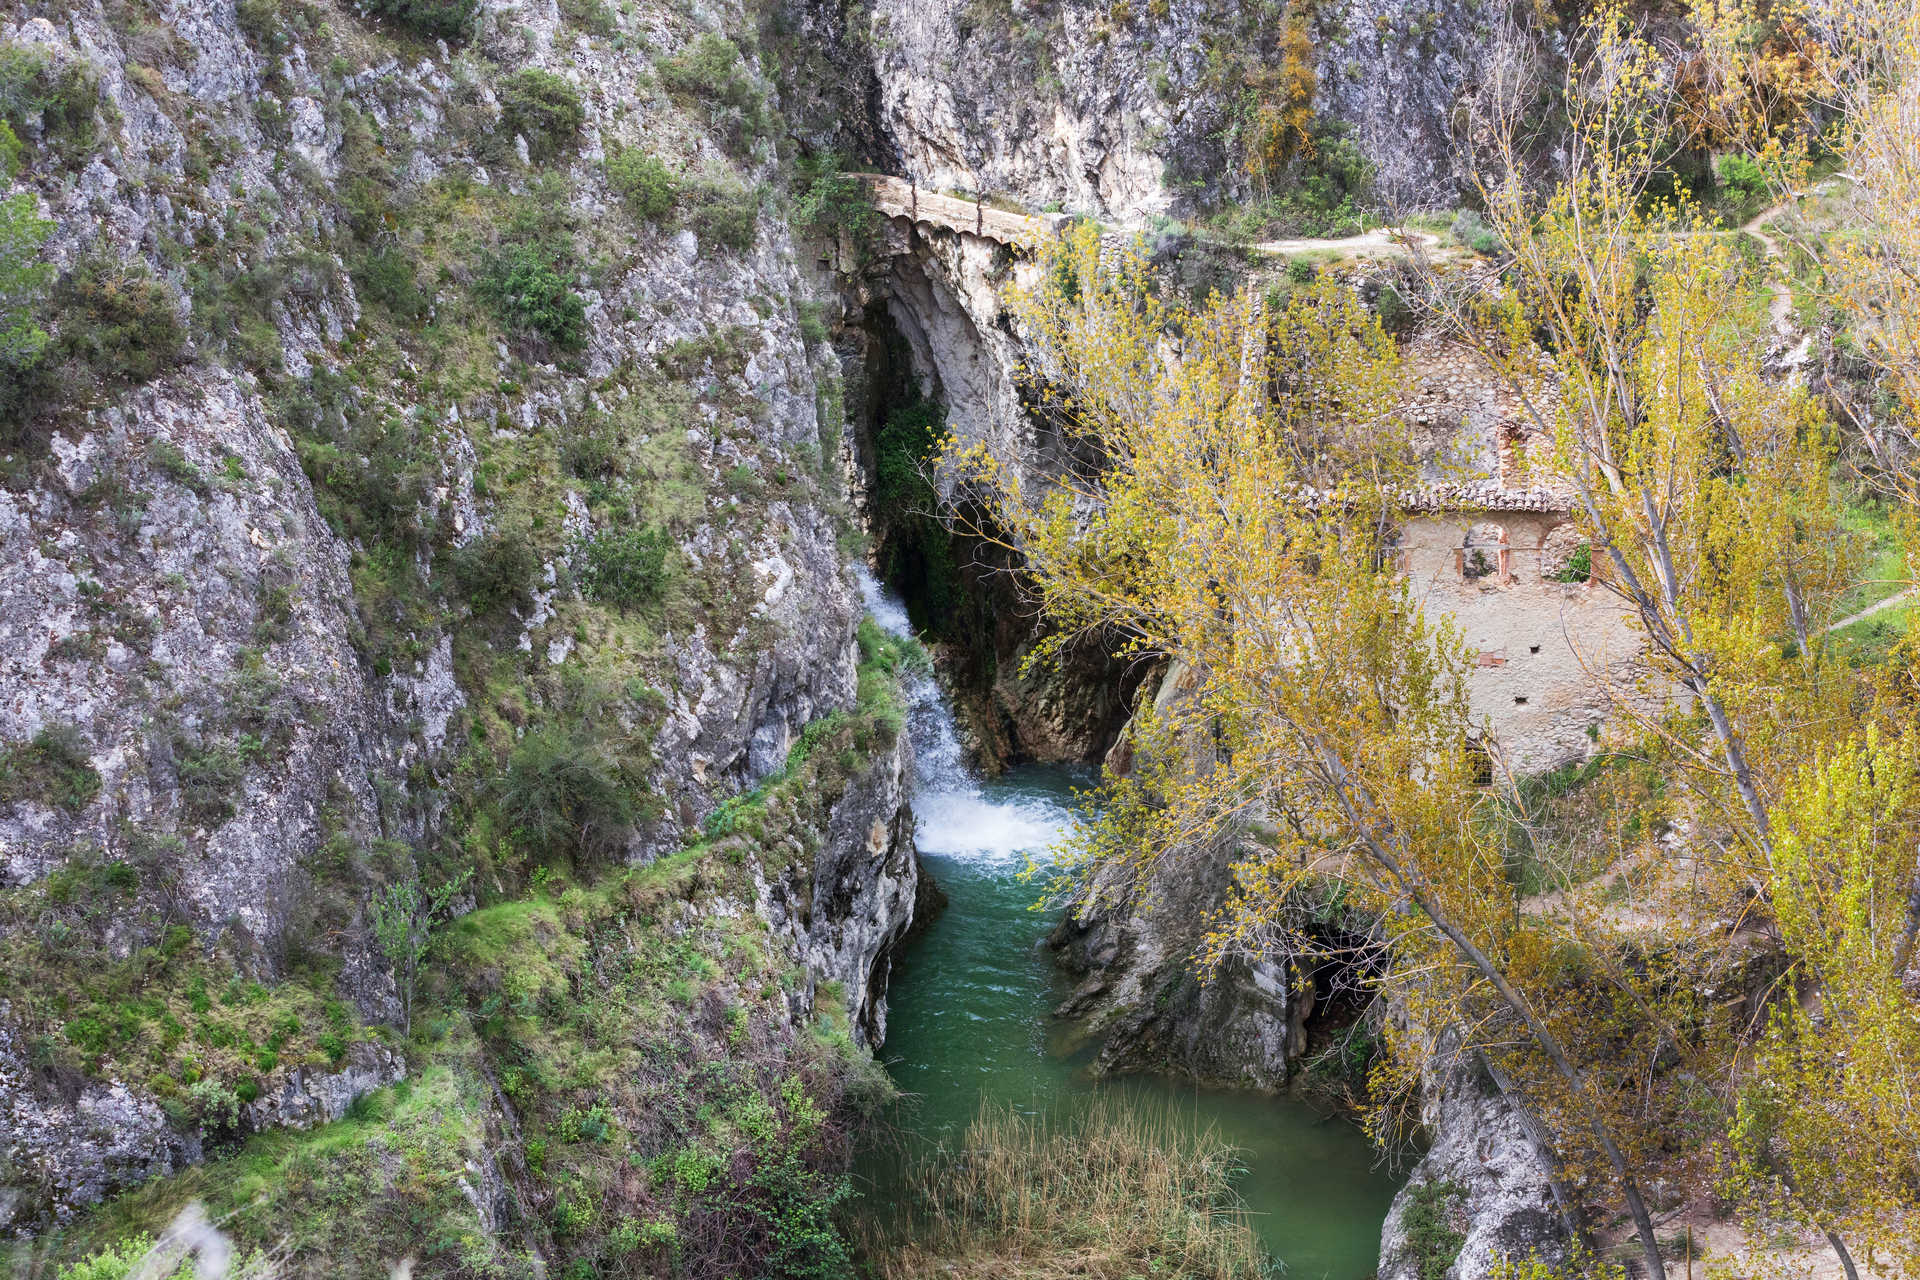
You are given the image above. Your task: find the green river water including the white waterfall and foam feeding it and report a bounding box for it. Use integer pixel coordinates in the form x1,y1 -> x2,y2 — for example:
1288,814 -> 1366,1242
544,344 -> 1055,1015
868,589 -> 1396,1280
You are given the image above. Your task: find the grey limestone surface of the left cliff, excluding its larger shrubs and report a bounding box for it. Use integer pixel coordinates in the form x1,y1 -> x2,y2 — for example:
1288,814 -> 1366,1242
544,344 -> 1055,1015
0,0 -> 914,1230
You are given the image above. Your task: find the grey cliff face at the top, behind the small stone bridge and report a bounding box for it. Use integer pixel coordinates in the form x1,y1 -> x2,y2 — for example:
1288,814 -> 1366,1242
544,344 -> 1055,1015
833,0 -> 1494,225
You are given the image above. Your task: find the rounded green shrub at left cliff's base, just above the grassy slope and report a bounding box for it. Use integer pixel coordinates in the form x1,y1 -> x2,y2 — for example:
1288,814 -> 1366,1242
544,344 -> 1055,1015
499,725 -> 634,854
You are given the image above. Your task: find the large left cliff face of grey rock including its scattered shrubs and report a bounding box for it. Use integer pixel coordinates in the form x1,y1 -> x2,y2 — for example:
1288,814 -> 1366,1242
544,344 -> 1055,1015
0,0 -> 918,1230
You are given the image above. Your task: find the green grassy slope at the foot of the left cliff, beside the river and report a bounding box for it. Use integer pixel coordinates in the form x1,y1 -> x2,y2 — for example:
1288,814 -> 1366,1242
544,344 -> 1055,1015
22,624 -> 924,1278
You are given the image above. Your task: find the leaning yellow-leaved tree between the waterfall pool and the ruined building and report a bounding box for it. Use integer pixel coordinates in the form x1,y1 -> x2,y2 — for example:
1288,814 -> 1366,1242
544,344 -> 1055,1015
947,228 -> 1665,1274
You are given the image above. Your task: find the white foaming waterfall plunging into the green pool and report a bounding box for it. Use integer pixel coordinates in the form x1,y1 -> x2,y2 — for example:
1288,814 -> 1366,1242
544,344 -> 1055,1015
854,566 -> 1073,865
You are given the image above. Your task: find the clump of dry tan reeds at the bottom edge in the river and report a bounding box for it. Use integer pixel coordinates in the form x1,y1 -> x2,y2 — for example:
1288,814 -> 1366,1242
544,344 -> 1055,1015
866,1098 -> 1271,1280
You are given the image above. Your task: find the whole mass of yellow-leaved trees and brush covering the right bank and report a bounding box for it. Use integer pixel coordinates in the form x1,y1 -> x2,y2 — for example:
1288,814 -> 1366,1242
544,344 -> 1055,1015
947,4 -> 1920,1276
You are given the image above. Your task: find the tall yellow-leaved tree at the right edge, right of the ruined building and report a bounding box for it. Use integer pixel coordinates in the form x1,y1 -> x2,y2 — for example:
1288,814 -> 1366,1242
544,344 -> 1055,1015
1440,6 -> 1920,1276
